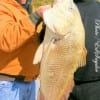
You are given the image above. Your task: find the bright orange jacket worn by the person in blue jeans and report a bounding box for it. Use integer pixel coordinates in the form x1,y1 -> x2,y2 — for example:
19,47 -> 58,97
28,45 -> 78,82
0,0 -> 39,81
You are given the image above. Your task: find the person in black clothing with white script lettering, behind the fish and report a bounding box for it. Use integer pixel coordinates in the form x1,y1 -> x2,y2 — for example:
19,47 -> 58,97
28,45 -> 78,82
68,0 -> 100,100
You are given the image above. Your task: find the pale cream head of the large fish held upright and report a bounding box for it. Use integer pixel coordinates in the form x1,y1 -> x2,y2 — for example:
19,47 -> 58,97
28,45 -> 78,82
43,0 -> 81,35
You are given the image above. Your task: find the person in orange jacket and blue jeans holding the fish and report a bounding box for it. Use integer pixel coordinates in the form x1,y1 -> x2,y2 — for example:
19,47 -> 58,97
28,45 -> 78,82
0,0 -> 50,100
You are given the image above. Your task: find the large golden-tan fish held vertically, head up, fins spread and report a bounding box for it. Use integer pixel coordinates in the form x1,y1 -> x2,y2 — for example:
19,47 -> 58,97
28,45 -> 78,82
33,0 -> 87,100
